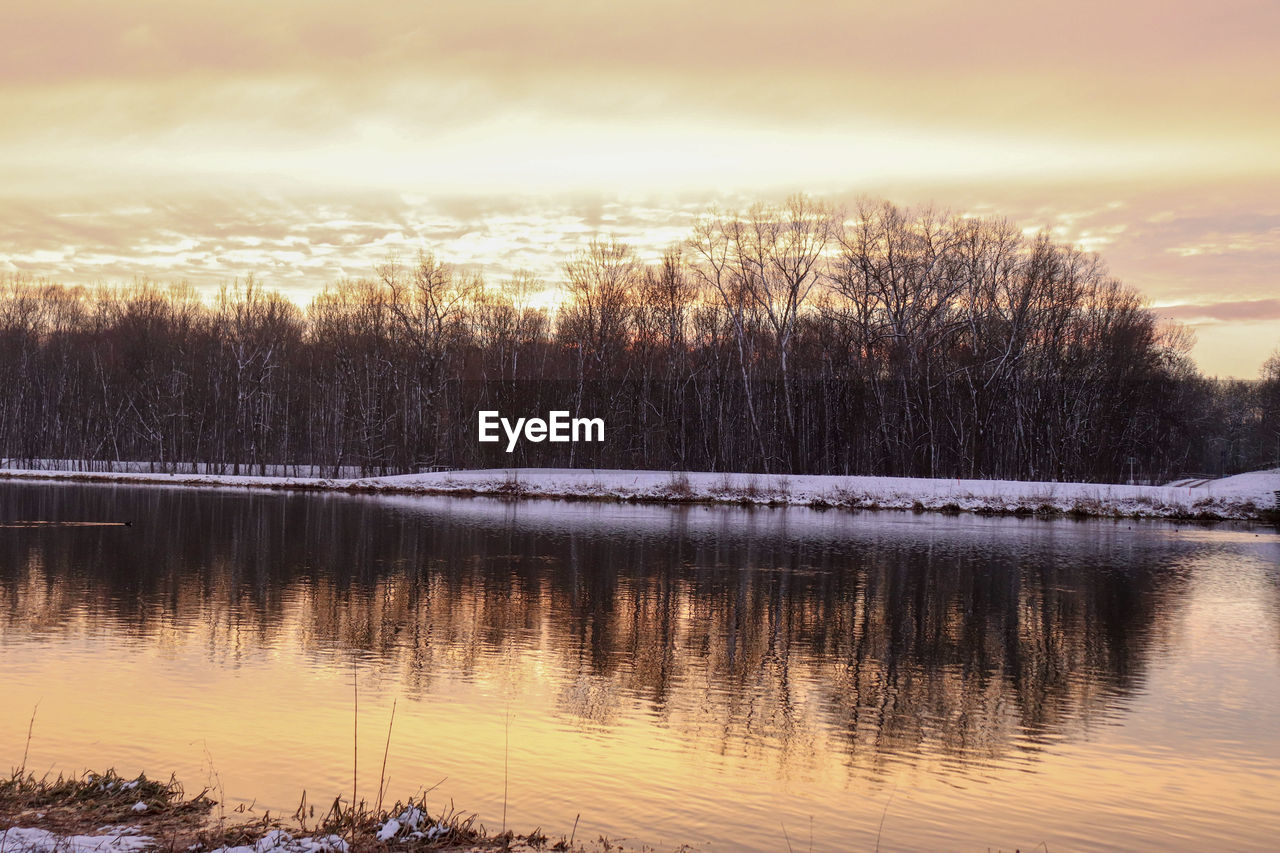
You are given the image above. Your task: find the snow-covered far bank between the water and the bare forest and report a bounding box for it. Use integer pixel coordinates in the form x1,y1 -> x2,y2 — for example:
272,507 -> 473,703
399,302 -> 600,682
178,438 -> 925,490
0,469 -> 1280,520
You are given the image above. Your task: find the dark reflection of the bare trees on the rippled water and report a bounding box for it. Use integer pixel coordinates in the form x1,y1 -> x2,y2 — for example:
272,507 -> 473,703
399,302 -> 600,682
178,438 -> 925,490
0,485 -> 1203,770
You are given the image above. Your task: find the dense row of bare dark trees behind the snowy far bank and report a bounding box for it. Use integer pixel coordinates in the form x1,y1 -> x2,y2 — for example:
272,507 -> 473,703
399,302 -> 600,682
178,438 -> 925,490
0,196 -> 1280,482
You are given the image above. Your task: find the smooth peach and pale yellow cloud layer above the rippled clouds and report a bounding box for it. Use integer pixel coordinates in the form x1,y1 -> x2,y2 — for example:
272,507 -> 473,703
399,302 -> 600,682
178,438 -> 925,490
0,0 -> 1280,179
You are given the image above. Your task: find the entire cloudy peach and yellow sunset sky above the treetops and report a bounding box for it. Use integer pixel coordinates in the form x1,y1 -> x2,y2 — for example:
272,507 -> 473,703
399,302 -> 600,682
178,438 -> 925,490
0,0 -> 1280,377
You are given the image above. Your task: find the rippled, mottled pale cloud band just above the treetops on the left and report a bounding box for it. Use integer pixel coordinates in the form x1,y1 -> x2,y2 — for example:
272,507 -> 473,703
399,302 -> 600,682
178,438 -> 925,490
0,192 -> 700,290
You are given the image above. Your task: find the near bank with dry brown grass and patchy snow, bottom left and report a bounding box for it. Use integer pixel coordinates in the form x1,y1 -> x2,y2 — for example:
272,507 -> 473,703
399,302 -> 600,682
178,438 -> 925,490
0,771 -> 640,853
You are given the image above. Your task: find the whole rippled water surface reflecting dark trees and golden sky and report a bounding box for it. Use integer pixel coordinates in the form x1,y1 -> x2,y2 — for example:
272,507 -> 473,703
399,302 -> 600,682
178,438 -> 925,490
0,485 -> 1280,849
